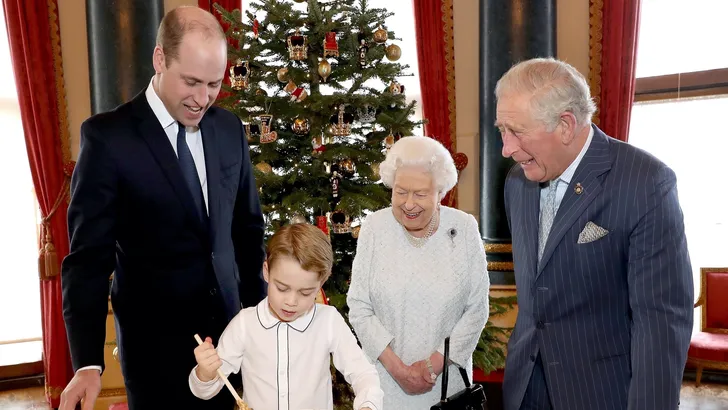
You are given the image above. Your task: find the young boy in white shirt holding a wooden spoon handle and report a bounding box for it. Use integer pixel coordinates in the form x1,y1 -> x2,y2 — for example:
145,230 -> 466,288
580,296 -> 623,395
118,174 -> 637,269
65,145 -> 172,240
189,224 -> 384,410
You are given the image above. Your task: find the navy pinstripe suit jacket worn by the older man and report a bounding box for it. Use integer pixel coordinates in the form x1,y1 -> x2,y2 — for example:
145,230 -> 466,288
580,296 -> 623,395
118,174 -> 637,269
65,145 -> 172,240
503,126 -> 694,410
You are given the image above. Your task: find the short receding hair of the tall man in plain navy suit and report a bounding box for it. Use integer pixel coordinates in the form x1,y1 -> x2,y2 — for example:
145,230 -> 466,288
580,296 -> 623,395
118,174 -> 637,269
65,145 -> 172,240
157,6 -> 227,67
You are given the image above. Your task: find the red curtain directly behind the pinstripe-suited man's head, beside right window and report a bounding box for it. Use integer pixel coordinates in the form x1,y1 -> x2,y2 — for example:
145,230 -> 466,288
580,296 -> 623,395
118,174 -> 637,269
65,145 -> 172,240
590,0 -> 641,141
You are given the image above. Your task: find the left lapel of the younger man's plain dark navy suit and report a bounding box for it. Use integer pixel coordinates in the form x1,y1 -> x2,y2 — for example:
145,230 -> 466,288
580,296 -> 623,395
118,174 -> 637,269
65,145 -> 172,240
134,93 -> 209,239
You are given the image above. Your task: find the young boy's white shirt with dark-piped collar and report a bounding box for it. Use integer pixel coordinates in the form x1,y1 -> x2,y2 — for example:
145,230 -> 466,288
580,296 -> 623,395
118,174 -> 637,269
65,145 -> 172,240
189,298 -> 384,410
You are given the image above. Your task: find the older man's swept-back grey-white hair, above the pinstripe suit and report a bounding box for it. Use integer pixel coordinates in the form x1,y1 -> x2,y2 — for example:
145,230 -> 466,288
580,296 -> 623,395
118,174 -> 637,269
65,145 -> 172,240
495,58 -> 596,130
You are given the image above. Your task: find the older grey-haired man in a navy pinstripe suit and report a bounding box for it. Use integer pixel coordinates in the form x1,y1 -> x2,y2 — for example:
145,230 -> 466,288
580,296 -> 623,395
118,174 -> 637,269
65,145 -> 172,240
496,59 -> 694,410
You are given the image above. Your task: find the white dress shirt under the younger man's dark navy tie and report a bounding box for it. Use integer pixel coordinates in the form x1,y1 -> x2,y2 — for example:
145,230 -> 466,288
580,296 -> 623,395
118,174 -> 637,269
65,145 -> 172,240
145,77 -> 209,212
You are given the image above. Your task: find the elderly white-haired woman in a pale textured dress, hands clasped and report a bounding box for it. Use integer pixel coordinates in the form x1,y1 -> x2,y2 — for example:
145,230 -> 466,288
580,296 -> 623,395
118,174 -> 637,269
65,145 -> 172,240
347,137 -> 490,410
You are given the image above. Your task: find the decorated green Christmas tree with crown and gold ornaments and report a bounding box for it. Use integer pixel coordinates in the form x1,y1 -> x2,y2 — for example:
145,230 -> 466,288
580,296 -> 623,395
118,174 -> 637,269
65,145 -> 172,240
216,0 -> 419,408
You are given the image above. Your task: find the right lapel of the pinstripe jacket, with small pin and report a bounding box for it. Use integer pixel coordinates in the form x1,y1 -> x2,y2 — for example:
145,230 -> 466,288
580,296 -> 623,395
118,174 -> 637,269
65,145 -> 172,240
536,126 -> 612,278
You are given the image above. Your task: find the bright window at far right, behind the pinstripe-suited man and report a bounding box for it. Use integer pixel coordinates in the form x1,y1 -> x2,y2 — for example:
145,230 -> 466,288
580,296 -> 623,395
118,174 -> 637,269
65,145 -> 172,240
629,0 -> 728,331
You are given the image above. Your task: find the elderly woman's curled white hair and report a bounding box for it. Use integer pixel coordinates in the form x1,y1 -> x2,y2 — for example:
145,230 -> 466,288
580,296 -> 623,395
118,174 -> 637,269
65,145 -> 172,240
379,136 -> 458,199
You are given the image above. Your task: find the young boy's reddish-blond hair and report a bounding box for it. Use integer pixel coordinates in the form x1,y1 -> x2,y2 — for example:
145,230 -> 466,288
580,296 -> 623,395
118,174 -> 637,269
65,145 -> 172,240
267,223 -> 334,283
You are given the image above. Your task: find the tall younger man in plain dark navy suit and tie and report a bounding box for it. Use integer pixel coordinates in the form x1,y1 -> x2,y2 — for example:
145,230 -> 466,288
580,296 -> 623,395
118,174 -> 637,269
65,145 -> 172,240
60,7 -> 265,410
